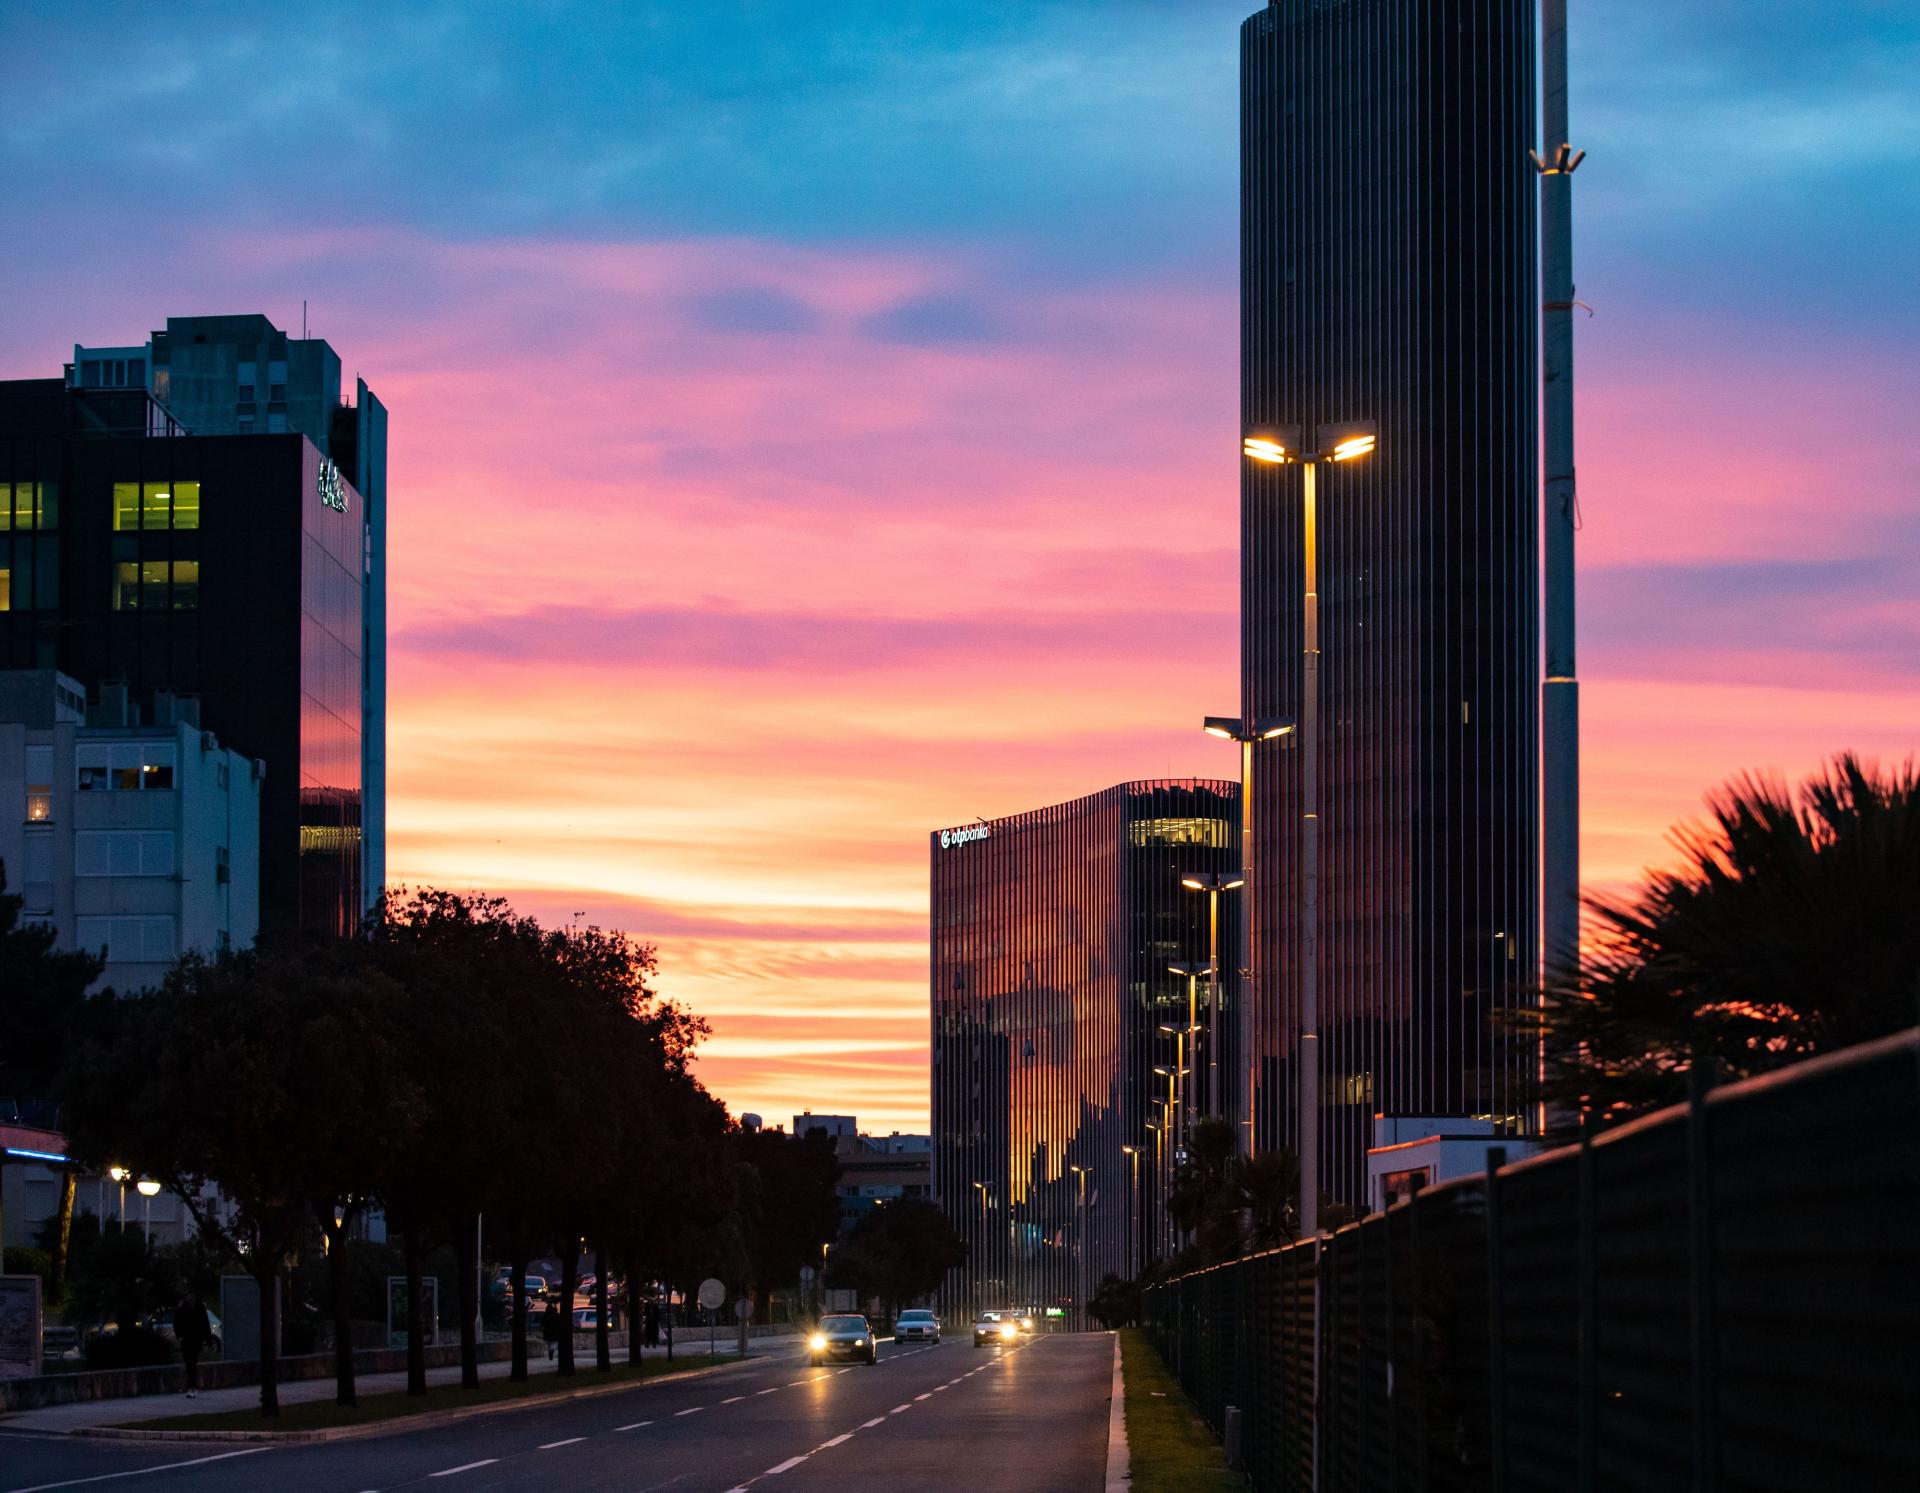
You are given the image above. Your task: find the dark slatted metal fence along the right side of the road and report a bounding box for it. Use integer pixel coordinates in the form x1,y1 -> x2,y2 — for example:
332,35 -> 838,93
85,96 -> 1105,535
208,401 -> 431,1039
1142,1031 -> 1920,1493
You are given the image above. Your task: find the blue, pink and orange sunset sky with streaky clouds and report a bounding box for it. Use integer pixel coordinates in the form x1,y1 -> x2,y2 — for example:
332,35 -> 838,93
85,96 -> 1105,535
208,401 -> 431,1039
0,0 -> 1920,1130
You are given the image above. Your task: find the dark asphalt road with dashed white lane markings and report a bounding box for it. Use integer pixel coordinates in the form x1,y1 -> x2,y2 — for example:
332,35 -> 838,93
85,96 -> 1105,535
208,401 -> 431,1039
0,1334 -> 1114,1493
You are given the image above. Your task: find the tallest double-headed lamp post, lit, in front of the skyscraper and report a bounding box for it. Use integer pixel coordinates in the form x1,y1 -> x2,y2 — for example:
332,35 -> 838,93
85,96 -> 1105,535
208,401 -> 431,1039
1240,424 -> 1379,1238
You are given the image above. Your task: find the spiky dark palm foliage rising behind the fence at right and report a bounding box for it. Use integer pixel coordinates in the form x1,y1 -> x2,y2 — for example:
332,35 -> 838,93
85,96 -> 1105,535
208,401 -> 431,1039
1528,754 -> 1920,1134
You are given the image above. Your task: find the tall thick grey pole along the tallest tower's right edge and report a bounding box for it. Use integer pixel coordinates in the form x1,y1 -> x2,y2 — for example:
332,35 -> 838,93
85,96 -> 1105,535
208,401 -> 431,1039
1538,0 -> 1580,1020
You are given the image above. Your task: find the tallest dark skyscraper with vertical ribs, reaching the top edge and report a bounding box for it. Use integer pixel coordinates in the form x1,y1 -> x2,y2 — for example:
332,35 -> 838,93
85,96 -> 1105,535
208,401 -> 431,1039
1240,0 -> 1538,1201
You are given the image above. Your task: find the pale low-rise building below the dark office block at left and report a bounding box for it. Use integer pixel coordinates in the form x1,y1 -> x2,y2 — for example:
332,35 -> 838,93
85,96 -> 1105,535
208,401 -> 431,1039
0,670 -> 265,994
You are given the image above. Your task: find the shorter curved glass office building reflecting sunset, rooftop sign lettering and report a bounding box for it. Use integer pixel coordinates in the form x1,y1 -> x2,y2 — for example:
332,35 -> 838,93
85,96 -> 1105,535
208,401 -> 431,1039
931,781 -> 1240,1320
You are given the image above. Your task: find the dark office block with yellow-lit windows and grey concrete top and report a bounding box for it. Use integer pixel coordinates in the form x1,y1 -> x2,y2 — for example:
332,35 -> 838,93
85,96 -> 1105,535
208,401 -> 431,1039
0,317 -> 386,933
